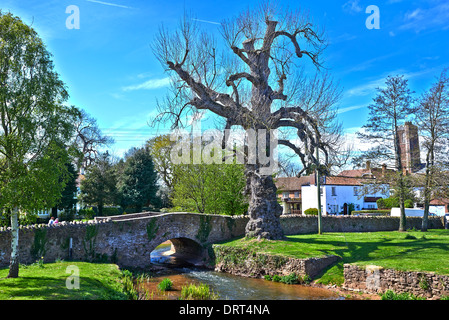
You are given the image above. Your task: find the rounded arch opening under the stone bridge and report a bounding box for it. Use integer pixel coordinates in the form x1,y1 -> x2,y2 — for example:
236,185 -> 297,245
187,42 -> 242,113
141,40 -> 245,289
150,238 -> 203,267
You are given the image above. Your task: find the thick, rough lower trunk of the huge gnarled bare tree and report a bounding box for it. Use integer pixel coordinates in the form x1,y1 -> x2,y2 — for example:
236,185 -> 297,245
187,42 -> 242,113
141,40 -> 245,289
245,173 -> 284,240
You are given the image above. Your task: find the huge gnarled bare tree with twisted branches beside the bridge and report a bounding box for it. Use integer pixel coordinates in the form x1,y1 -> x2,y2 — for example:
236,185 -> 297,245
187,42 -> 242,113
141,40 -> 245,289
153,4 -> 340,239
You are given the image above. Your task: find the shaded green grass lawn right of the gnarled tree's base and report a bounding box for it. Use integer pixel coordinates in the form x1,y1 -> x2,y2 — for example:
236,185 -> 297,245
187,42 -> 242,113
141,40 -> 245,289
222,229 -> 449,285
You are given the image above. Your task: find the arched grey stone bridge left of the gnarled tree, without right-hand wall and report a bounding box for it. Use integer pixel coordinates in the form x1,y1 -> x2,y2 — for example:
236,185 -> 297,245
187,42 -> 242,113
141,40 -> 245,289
0,213 -> 247,267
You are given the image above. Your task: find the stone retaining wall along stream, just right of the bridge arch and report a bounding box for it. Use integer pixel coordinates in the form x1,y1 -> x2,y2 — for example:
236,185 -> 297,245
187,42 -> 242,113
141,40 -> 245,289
212,245 -> 339,278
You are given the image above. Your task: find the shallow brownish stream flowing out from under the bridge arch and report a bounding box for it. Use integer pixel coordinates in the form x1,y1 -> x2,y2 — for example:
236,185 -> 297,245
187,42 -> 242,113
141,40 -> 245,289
143,244 -> 344,300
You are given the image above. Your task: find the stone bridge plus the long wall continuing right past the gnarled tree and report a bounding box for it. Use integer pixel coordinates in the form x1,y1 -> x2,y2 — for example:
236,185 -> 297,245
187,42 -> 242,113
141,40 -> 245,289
0,212 -> 443,267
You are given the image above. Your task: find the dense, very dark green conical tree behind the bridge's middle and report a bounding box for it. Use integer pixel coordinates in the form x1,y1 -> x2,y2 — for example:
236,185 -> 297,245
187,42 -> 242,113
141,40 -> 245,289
118,148 -> 160,212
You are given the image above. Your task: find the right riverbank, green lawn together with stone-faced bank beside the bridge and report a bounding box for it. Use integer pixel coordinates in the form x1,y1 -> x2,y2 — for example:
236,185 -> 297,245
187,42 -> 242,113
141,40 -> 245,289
216,229 -> 449,296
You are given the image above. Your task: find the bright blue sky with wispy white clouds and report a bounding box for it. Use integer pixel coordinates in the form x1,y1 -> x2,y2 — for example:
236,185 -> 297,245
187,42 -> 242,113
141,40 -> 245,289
0,0 -> 449,155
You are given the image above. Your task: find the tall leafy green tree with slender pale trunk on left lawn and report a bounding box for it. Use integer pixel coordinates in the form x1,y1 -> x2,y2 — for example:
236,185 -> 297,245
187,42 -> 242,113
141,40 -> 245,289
0,11 -> 79,278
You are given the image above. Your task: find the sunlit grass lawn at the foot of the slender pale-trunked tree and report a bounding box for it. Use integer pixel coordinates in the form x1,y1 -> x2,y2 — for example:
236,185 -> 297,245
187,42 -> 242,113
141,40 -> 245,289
0,261 -> 127,300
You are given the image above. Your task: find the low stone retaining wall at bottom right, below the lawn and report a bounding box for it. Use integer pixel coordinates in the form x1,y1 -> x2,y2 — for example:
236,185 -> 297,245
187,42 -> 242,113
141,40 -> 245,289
343,264 -> 449,299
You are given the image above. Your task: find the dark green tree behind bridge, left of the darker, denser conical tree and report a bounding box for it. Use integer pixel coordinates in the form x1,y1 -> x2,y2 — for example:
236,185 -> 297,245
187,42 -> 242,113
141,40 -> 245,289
81,152 -> 118,216
